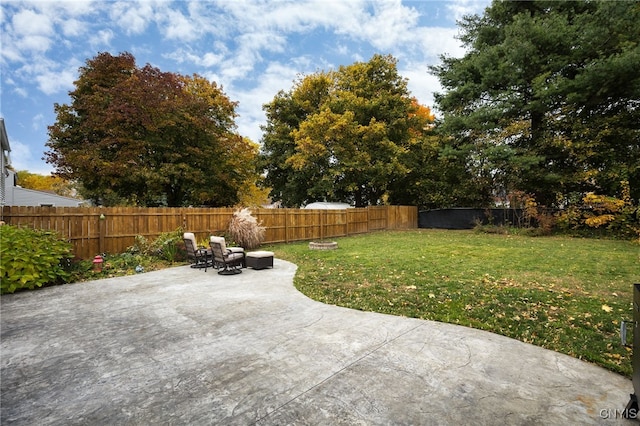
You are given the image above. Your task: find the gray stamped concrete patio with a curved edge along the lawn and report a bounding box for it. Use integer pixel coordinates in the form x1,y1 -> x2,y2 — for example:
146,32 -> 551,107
0,259 -> 635,425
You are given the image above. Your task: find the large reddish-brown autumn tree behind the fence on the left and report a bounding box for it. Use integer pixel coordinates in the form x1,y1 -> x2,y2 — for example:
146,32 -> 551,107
45,53 -> 257,206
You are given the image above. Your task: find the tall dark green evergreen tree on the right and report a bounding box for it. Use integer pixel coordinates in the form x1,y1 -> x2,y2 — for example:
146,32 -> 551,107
432,1 -> 640,205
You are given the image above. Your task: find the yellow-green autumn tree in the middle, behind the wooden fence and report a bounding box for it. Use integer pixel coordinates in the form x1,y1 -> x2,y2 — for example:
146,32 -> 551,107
261,55 -> 424,207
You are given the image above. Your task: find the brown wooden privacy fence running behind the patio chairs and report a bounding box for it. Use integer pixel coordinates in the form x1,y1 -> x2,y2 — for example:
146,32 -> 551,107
2,206 -> 418,259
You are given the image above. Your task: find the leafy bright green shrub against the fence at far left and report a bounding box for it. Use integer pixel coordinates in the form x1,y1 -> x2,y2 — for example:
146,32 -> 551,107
0,225 -> 72,294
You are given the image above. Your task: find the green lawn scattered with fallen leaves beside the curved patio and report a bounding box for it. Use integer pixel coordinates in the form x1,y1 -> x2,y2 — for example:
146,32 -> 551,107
267,229 -> 640,377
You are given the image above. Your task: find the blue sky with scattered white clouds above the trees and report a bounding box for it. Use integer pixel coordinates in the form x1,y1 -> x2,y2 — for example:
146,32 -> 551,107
0,0 -> 490,174
